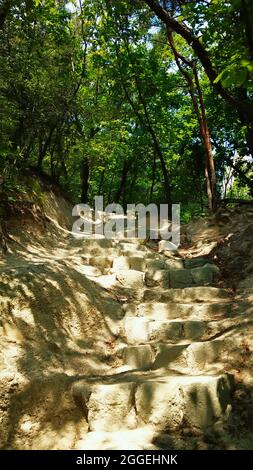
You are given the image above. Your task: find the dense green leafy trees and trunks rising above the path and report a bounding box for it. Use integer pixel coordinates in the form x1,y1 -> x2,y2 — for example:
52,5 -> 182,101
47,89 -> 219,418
0,0 -> 253,220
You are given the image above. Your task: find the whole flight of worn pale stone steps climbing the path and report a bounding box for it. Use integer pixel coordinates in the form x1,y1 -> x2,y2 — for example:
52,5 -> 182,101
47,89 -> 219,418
73,240 -> 233,449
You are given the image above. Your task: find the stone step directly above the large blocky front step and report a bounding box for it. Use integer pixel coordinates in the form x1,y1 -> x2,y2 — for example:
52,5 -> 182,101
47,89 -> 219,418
118,338 -> 225,375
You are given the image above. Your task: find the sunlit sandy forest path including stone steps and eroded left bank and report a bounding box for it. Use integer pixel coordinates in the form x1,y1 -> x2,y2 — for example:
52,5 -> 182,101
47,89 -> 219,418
0,215 -> 253,450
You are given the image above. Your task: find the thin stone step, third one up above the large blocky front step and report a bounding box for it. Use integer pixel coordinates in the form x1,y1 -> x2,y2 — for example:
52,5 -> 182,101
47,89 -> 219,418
123,302 -> 233,321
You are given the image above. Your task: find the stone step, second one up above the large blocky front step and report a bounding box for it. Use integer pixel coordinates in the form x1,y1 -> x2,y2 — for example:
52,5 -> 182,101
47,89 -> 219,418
124,314 -> 230,345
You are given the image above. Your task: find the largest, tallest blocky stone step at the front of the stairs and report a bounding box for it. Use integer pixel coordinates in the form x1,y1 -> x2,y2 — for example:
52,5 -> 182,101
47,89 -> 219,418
72,374 -> 233,433
